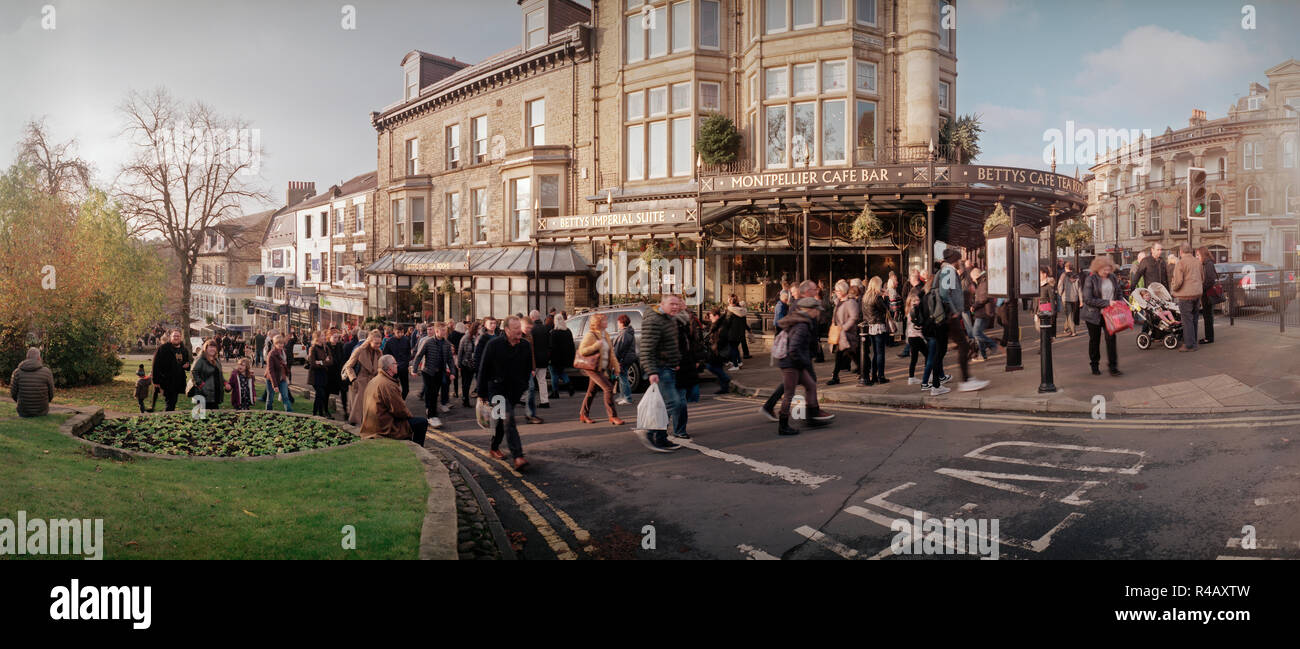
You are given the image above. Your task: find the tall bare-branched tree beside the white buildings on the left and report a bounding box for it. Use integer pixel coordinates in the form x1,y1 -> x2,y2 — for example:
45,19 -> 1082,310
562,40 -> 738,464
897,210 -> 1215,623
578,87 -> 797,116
117,88 -> 269,338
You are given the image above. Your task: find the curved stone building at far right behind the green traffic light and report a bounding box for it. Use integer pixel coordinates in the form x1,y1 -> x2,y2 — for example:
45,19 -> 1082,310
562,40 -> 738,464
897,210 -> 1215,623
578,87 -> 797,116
1087,60 -> 1300,268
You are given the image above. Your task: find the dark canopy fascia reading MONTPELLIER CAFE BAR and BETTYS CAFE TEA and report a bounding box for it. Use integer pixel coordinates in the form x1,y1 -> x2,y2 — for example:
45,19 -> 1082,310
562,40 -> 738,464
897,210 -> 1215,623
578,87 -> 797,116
699,163 -> 1087,198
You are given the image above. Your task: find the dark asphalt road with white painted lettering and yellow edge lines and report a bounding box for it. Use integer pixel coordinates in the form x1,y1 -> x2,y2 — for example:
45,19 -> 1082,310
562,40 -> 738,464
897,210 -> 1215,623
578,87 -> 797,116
411,385 -> 1300,561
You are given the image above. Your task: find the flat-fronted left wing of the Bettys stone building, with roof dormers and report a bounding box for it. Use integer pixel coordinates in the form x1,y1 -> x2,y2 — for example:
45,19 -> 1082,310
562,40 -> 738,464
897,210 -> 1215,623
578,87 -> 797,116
365,0 -> 594,323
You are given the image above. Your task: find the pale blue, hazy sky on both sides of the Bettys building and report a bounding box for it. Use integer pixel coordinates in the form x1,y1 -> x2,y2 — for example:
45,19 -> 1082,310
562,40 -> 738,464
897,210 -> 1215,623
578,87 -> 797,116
0,0 -> 1300,199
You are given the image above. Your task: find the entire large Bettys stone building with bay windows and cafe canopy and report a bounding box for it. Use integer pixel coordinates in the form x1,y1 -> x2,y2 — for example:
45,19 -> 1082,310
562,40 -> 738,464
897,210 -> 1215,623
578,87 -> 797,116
366,0 -> 1084,321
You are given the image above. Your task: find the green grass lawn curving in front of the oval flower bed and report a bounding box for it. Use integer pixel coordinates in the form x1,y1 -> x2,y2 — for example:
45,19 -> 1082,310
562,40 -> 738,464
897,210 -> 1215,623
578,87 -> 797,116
0,413 -> 429,559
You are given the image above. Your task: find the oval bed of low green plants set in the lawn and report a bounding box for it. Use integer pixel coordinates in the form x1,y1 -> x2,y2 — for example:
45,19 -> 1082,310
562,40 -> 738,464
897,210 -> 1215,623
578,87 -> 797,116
82,411 -> 356,458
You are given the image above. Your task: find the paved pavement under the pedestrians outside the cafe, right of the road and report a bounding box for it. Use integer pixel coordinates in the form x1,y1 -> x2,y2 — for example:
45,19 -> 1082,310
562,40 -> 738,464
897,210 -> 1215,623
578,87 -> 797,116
736,310 -> 1300,415
